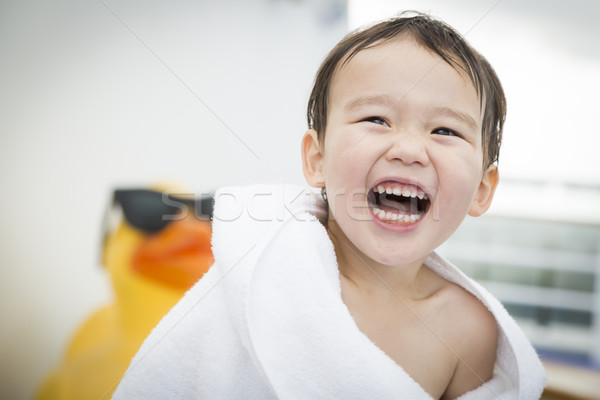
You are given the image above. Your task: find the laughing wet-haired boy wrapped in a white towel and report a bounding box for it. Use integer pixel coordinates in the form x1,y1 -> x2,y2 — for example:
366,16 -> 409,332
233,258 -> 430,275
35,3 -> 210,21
115,10 -> 544,399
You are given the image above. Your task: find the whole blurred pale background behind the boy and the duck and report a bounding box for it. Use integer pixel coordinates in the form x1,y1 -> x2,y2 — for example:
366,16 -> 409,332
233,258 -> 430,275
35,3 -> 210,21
0,0 -> 600,399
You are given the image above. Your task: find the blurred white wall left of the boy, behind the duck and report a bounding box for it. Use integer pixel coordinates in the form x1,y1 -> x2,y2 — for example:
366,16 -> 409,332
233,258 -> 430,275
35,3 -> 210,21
0,0 -> 346,399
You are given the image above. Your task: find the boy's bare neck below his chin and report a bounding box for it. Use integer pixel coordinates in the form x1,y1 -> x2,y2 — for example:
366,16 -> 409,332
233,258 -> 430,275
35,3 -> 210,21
327,220 -> 435,300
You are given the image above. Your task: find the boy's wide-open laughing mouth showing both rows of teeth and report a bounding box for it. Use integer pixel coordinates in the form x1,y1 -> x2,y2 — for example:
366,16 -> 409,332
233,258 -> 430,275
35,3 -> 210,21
367,181 -> 431,225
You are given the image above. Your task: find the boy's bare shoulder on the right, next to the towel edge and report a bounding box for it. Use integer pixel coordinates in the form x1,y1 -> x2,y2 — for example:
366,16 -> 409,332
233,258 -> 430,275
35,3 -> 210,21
442,283 -> 498,399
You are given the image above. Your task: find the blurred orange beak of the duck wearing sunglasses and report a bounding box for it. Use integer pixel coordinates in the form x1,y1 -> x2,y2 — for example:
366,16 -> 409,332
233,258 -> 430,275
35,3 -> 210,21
132,217 -> 214,291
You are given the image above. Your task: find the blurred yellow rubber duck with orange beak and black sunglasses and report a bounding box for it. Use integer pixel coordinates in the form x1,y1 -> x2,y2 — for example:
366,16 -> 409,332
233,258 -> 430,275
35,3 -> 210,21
36,189 -> 213,400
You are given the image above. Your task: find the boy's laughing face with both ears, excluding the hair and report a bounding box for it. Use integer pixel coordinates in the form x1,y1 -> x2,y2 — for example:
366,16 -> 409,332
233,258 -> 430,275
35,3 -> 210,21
303,39 -> 497,265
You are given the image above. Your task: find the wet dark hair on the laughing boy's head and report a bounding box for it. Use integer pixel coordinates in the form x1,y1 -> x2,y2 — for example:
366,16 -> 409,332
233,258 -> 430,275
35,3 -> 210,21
307,12 -> 506,169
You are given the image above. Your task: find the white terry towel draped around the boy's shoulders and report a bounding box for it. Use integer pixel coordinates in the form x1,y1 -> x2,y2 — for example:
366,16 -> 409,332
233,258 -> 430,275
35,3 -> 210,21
113,185 -> 545,400
